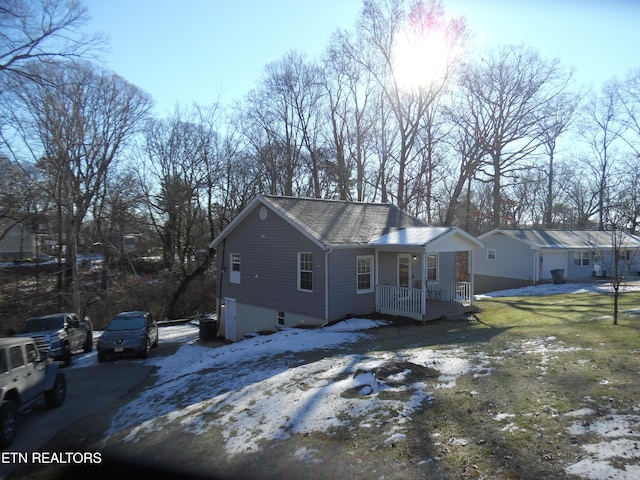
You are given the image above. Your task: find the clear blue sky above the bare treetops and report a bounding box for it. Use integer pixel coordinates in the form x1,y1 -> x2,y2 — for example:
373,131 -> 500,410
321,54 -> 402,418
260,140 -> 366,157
85,0 -> 640,115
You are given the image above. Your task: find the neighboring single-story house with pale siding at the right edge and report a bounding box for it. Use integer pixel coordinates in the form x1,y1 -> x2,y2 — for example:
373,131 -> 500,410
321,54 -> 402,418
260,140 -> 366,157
474,229 -> 640,293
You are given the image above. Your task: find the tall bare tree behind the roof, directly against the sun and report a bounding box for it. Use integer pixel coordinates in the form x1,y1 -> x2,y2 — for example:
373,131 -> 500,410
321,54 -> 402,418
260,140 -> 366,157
358,0 -> 468,209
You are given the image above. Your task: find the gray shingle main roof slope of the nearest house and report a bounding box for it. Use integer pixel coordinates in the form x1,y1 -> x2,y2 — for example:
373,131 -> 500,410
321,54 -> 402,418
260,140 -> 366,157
263,195 -> 429,246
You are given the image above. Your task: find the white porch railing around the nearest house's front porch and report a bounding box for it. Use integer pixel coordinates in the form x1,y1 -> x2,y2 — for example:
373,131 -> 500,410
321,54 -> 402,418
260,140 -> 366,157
376,280 -> 471,320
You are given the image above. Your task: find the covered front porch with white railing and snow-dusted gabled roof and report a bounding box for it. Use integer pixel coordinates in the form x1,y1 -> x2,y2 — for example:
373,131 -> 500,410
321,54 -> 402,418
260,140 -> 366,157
371,227 -> 482,322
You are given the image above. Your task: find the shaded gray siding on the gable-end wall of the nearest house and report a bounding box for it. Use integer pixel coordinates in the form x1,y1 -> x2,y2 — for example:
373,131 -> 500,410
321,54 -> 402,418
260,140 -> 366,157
216,204 -> 325,323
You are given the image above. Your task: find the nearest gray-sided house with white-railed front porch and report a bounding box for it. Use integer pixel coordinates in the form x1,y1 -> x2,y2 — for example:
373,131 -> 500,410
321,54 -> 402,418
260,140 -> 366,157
210,195 -> 481,341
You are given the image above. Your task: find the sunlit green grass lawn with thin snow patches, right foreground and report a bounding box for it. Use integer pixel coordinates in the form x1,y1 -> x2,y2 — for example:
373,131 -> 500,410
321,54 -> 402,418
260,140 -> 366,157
424,292 -> 640,478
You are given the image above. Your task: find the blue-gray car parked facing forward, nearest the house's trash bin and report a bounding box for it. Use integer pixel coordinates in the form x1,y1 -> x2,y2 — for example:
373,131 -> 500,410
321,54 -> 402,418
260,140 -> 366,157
96,311 -> 158,362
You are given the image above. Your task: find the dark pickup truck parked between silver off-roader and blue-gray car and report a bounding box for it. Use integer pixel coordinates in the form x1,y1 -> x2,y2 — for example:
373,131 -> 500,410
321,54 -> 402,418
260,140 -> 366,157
13,313 -> 93,366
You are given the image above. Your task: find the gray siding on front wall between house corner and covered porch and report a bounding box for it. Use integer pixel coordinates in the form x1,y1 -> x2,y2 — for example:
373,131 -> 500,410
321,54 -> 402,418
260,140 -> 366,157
329,248 -> 377,321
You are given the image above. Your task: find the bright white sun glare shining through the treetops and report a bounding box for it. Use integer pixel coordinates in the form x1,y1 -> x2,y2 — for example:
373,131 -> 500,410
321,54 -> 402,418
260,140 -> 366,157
393,28 -> 451,90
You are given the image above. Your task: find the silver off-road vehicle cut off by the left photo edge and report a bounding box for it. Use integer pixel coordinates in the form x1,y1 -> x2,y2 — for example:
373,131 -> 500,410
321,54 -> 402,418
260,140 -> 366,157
0,337 -> 67,448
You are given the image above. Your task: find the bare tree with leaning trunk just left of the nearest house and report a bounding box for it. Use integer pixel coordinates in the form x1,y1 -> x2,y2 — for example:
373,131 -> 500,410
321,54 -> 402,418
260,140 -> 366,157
142,105 -> 228,318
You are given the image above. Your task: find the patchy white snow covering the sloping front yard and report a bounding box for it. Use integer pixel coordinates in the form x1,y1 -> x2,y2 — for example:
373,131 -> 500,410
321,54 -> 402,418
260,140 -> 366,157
71,284 -> 640,479
